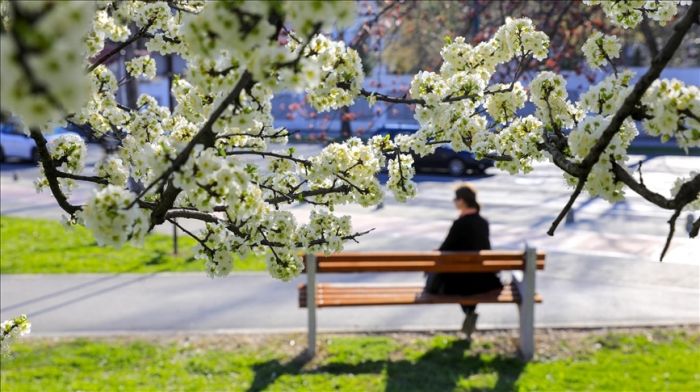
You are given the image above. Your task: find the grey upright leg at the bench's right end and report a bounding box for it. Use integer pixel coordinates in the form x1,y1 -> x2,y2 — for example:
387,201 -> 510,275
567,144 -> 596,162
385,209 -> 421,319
519,247 -> 537,361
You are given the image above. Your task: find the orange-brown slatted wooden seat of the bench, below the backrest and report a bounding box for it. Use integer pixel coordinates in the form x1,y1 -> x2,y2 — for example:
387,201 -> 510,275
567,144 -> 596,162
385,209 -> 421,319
299,283 -> 542,308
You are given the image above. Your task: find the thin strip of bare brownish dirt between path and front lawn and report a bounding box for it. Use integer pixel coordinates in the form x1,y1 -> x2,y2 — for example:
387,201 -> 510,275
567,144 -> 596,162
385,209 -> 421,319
24,325 -> 700,362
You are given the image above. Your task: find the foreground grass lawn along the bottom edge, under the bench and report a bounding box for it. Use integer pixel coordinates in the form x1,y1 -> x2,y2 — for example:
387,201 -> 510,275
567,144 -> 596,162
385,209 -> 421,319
2,328 -> 700,392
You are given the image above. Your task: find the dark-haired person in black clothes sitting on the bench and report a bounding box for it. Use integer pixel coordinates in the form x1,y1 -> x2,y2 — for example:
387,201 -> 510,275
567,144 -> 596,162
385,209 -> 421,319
425,184 -> 503,337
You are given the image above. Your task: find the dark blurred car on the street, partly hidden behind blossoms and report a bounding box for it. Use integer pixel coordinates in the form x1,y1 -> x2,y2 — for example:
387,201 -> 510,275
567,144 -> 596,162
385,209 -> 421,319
373,124 -> 493,176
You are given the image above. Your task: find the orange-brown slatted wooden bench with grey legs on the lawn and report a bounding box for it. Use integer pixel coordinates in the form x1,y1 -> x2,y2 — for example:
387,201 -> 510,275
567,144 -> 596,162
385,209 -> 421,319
299,248 -> 545,359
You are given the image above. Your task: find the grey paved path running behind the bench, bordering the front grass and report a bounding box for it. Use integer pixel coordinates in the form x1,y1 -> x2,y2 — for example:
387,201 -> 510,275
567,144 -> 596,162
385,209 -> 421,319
0,253 -> 700,335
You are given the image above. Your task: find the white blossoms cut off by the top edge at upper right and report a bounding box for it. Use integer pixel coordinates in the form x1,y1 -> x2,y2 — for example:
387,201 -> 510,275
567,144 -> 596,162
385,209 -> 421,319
583,0 -> 688,29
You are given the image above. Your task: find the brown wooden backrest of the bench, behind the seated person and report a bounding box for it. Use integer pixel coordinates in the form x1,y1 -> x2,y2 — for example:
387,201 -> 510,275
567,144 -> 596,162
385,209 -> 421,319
305,250 -> 545,273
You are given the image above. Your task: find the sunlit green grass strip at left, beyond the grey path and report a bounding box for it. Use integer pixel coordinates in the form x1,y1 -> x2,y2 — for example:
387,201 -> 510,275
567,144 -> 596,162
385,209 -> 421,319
0,216 -> 265,274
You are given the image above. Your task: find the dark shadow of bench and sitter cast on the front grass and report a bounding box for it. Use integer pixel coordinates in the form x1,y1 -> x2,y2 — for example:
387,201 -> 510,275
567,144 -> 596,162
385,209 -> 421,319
248,341 -> 525,392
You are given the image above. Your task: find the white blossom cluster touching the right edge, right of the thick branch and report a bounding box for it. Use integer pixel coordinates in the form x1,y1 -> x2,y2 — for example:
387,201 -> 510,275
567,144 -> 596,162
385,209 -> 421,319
642,79 -> 700,149
